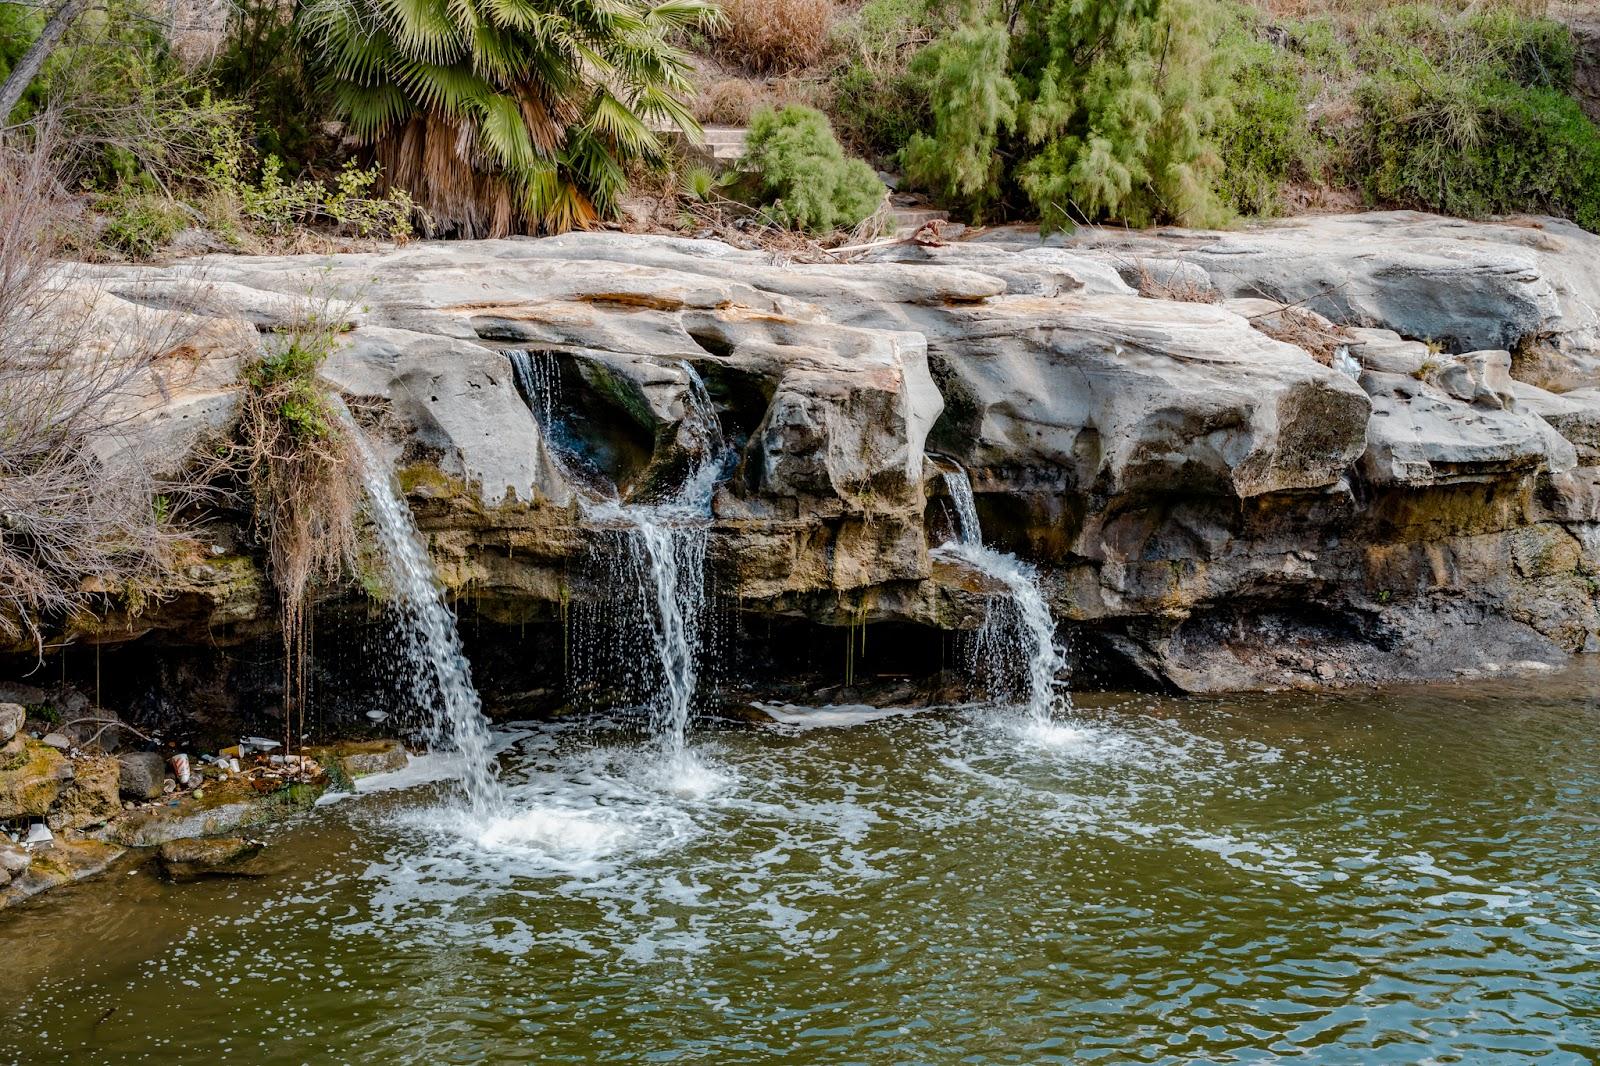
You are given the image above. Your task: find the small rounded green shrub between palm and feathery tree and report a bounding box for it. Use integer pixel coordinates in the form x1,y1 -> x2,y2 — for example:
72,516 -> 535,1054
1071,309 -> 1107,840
741,106 -> 885,234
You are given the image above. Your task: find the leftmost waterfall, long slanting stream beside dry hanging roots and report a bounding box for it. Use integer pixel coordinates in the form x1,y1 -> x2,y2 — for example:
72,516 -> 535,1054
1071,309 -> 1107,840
347,419 -> 501,815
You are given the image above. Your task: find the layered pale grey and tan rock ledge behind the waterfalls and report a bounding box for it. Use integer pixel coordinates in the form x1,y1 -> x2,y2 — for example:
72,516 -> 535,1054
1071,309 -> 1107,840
40,213 -> 1600,691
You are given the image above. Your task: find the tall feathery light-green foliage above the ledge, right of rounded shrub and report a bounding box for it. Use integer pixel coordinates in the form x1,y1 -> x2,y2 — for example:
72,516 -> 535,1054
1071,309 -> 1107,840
904,0 -> 1227,227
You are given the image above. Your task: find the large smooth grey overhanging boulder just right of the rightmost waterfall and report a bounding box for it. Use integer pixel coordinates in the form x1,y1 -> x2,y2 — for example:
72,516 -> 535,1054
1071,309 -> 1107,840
930,295 -> 1370,498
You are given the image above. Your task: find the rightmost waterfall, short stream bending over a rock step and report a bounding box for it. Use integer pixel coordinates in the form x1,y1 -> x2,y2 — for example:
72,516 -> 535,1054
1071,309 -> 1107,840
936,467 -> 1067,725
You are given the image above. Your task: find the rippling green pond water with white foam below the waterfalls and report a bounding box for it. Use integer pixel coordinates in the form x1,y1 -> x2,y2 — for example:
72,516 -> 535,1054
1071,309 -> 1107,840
0,666 -> 1600,1064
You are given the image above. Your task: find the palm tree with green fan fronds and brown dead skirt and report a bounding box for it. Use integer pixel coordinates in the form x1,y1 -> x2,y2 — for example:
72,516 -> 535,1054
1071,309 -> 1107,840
298,0 -> 720,237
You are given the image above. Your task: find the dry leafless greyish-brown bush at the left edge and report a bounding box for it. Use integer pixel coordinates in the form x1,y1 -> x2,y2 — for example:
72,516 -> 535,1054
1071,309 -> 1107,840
0,123 -> 196,648
